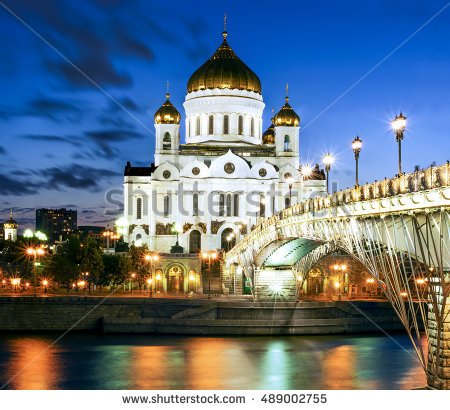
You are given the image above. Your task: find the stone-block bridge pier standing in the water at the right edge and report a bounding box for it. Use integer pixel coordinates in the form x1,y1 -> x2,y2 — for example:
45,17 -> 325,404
427,286 -> 450,390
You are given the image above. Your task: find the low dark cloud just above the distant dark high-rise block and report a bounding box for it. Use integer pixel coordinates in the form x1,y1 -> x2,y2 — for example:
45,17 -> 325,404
38,163 -> 119,192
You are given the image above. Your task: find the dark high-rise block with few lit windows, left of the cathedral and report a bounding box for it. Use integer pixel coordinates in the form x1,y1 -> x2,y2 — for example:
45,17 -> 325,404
36,208 -> 77,244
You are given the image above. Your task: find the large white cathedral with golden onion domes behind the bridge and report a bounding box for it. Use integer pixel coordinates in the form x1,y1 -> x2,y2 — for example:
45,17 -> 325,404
123,25 -> 326,294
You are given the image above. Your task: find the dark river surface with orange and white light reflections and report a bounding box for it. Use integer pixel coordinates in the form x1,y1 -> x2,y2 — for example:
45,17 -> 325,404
0,334 -> 425,389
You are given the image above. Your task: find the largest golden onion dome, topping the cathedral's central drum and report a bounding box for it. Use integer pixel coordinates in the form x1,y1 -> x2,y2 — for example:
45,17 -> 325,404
187,31 -> 261,94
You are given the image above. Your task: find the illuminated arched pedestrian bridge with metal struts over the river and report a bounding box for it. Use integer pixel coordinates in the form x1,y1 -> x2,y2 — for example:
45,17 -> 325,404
225,162 -> 450,388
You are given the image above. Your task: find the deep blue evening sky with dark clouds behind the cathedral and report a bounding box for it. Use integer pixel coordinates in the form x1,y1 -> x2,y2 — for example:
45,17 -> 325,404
0,0 -> 450,229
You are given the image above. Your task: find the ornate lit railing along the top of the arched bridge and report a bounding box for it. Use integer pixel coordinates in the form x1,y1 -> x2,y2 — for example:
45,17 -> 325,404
280,161 -> 450,223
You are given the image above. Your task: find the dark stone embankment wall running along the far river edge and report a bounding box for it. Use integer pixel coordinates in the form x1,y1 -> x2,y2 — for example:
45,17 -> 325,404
0,296 -> 403,335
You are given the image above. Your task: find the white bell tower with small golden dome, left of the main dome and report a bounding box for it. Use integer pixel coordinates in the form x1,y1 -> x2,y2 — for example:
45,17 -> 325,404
154,87 -> 181,166
